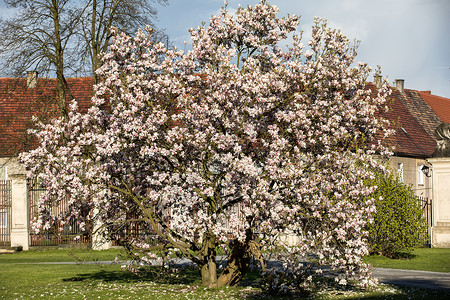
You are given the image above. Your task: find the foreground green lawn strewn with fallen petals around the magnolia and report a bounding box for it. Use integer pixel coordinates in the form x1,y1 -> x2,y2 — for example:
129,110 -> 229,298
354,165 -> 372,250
0,249 -> 450,300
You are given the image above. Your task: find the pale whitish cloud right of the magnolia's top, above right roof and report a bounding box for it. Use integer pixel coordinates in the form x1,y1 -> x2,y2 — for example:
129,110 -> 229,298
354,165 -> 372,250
273,0 -> 450,97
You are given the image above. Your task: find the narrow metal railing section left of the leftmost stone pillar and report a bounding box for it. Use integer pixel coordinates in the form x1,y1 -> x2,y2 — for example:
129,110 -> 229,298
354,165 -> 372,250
0,180 -> 12,246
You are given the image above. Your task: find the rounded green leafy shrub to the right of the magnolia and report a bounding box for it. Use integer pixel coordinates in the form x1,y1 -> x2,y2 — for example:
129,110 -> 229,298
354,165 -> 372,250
368,173 -> 428,258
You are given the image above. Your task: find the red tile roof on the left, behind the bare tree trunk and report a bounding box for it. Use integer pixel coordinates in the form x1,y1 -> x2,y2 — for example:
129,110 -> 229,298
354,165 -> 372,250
0,78 -> 92,157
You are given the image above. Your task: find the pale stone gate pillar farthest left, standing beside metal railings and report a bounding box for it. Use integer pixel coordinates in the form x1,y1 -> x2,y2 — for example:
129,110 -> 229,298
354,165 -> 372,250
9,174 -> 30,250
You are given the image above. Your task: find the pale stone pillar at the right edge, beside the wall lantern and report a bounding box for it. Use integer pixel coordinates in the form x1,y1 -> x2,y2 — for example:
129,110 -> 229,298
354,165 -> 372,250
428,157 -> 450,248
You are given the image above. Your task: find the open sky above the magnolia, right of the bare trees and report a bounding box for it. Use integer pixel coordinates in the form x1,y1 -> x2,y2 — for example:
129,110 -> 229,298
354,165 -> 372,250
156,0 -> 450,98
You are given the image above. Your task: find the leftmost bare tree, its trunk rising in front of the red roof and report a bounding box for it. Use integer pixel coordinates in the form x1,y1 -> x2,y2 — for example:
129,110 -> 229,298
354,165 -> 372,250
0,0 -> 82,116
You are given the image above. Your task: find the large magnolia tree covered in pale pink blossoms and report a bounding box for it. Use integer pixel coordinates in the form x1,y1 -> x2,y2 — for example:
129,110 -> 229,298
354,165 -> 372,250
21,1 -> 394,286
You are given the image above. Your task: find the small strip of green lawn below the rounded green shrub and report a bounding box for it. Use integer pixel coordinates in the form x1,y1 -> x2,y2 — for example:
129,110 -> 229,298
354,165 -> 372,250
364,248 -> 450,272
